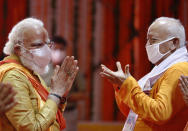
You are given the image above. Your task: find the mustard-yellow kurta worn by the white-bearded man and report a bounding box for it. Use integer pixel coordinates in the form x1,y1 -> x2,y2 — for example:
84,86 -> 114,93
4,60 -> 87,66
0,56 -> 64,131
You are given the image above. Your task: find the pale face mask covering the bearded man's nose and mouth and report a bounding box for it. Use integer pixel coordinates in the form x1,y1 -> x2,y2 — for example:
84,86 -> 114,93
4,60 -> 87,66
20,45 -> 51,74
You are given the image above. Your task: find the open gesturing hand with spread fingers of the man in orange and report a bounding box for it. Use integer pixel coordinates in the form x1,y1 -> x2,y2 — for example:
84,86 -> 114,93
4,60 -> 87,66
100,62 -> 131,86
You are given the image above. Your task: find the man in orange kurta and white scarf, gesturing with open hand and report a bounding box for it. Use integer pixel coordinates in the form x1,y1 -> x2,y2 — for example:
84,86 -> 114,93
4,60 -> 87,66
101,17 -> 188,131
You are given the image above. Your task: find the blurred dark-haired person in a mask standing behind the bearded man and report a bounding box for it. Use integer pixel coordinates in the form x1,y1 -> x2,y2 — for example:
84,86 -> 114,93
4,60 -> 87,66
42,36 -> 86,131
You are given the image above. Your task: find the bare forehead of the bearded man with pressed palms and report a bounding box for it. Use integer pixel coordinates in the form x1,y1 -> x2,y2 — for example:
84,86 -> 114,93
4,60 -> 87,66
22,25 -> 49,43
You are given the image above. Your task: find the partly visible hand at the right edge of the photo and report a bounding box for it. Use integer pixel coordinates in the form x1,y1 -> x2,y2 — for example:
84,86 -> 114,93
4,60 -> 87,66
179,76 -> 188,105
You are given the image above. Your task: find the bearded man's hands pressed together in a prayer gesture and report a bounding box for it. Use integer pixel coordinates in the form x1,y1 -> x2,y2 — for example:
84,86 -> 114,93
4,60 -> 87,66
51,56 -> 79,97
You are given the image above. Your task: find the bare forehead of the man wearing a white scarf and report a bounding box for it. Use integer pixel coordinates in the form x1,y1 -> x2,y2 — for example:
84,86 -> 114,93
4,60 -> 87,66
147,21 -> 169,39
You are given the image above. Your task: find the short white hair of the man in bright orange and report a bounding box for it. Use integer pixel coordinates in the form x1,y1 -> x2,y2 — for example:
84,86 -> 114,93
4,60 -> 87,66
148,17 -> 186,47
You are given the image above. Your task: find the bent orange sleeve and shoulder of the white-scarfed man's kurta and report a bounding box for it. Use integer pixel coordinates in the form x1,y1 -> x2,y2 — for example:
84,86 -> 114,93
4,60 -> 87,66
116,62 -> 188,125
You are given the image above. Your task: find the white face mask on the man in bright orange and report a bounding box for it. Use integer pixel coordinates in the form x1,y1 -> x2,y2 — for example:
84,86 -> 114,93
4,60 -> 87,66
146,37 -> 175,64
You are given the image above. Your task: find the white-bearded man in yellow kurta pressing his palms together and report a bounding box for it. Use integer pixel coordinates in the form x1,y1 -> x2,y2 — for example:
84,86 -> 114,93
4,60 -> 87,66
0,18 -> 79,131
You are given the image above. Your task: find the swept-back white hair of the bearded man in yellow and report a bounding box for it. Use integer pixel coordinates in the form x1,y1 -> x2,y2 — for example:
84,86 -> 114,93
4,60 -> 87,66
3,18 -> 44,55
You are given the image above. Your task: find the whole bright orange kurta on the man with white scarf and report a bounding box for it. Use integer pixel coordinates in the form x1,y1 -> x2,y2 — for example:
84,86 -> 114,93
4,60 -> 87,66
115,62 -> 188,131
